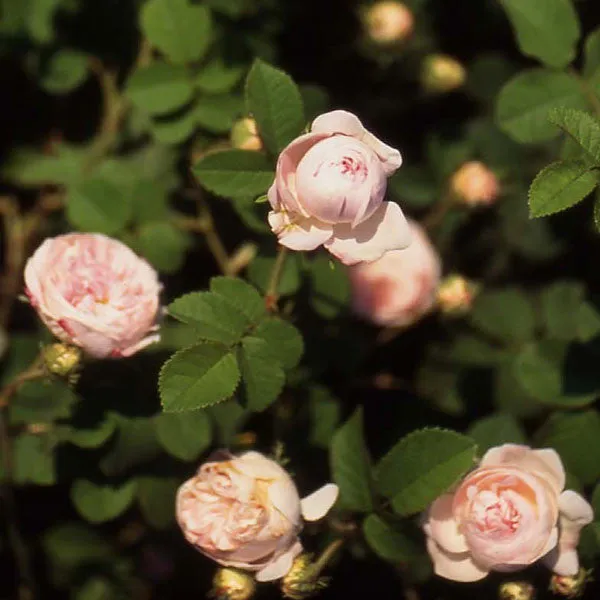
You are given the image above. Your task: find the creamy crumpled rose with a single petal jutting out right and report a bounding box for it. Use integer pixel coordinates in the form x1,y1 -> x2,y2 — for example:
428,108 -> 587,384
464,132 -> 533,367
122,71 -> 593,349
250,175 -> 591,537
177,452 -> 338,581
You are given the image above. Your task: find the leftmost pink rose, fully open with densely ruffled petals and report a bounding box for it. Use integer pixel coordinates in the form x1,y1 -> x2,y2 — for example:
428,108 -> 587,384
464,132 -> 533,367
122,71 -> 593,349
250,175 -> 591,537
25,233 -> 161,358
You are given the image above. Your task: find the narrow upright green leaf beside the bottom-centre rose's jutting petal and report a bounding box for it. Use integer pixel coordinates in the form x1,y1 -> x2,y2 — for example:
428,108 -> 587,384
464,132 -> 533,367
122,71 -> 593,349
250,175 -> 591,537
330,408 -> 373,512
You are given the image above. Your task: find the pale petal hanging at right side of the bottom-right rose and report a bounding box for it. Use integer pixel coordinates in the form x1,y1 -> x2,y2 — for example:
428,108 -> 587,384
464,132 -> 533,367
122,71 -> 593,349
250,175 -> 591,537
544,490 -> 594,577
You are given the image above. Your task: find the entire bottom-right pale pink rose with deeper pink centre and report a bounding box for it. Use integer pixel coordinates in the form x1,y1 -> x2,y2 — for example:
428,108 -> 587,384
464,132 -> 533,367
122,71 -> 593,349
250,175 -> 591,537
424,444 -> 593,581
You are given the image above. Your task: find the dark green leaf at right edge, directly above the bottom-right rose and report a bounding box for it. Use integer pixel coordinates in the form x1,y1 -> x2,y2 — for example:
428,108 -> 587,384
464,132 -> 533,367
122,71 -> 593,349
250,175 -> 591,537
536,409 -> 600,485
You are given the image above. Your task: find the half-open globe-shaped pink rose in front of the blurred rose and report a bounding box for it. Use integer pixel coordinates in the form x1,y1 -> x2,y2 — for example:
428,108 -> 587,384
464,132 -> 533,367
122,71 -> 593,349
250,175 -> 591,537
269,110 -> 410,265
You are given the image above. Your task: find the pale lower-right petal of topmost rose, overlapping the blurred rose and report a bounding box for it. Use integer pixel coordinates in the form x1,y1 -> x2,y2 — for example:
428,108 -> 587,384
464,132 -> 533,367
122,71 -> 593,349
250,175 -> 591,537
324,202 -> 411,265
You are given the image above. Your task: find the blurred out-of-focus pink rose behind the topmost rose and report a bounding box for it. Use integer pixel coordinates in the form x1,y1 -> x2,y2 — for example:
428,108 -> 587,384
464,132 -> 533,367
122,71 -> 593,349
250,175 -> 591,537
349,221 -> 441,327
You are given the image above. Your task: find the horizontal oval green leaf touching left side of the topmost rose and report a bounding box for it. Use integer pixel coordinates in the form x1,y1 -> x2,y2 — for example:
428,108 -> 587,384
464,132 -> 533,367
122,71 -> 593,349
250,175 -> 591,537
192,150 -> 275,198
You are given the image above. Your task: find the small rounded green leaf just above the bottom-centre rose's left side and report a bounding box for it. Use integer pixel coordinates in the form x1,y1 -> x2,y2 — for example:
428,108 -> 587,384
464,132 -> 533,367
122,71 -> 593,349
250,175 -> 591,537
156,411 -> 212,460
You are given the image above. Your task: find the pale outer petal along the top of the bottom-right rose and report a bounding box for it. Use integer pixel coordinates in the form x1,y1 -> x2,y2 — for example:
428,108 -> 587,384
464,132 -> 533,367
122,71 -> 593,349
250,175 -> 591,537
480,444 -> 565,494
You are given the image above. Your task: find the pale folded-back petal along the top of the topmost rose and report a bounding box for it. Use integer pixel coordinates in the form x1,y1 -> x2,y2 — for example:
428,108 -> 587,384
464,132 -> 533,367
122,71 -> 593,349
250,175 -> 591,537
311,110 -> 402,175
